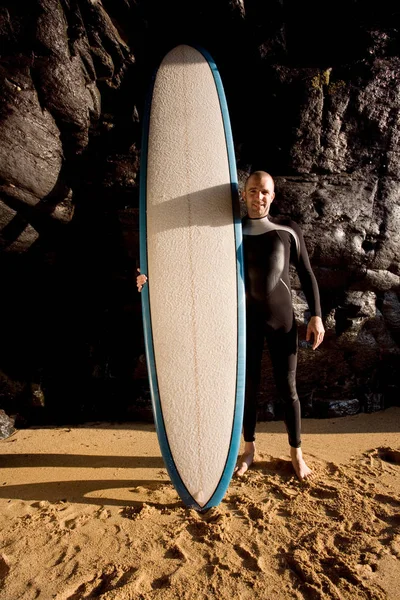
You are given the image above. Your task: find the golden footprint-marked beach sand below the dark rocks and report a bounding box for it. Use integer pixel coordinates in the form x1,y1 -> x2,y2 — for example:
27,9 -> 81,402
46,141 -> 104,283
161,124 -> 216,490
0,407 -> 400,600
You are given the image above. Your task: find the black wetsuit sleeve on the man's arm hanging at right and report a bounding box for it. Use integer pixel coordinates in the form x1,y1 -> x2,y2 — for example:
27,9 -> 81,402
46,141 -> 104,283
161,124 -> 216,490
290,221 -> 322,317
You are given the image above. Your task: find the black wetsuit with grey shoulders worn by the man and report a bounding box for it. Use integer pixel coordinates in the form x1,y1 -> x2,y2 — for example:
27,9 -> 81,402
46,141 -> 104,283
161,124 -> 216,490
243,216 -> 321,448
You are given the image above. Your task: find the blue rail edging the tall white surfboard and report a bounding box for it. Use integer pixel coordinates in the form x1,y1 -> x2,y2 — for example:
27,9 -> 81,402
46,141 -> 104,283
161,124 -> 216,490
139,44 -> 246,512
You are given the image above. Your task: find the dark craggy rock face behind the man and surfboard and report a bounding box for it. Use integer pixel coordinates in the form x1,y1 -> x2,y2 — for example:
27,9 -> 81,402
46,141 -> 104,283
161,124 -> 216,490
0,0 -> 400,426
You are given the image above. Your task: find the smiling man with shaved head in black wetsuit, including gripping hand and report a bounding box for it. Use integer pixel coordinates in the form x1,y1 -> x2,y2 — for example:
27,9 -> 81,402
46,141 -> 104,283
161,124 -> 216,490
137,171 -> 324,480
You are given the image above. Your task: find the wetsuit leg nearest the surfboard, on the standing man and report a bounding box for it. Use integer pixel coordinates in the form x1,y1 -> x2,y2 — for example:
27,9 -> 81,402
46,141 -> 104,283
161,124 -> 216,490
243,308 -> 265,442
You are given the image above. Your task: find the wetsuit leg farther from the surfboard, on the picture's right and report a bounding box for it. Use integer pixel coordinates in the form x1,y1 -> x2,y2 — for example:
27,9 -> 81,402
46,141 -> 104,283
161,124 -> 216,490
266,318 -> 301,448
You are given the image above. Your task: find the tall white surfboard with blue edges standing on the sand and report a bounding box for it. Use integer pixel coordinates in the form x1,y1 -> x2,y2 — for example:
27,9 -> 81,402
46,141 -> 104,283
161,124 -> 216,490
139,45 -> 245,511
